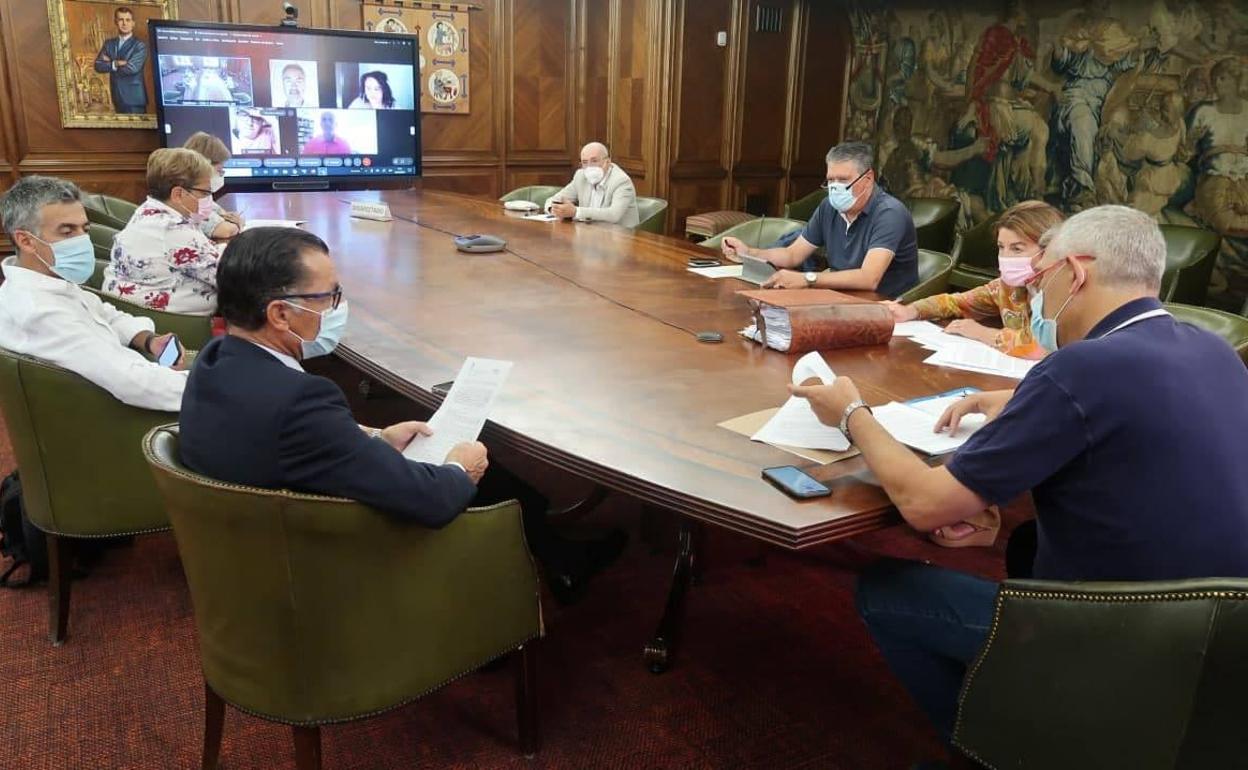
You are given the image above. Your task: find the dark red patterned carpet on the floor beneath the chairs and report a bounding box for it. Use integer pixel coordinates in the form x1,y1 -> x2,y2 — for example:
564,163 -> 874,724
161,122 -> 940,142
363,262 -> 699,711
0,411 -> 1001,770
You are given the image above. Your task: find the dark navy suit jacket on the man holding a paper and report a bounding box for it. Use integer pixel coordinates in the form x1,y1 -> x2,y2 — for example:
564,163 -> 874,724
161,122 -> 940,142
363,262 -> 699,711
178,336 -> 477,527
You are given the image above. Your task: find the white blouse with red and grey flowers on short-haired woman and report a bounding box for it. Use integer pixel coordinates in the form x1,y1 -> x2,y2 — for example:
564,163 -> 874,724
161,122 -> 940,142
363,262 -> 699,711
102,197 -> 221,316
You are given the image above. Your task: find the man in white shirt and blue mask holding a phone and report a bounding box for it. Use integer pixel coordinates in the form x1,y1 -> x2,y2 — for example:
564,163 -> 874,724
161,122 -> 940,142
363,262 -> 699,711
0,176 -> 186,412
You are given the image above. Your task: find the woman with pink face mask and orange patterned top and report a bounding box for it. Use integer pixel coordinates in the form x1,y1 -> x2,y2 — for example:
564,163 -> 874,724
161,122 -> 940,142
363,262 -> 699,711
885,201 -> 1062,358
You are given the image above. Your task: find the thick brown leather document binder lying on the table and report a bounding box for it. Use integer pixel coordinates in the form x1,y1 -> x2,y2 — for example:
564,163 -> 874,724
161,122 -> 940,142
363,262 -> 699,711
738,288 -> 892,353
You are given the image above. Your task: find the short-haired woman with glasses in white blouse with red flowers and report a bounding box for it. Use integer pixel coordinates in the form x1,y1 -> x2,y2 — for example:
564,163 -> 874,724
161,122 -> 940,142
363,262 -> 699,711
104,149 -> 221,316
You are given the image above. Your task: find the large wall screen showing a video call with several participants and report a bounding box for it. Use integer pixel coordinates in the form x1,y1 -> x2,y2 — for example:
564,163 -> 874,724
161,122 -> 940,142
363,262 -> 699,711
154,27 -> 419,181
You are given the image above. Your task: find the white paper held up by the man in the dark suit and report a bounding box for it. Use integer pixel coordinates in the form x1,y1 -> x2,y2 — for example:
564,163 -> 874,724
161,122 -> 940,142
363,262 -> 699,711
403,357 -> 512,464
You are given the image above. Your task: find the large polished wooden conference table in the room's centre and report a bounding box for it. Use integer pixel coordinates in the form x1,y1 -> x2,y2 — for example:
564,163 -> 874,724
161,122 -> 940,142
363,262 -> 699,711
229,188 -> 1015,670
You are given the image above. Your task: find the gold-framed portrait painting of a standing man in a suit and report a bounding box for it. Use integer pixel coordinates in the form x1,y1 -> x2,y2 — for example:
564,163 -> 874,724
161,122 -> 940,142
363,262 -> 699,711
47,0 -> 177,129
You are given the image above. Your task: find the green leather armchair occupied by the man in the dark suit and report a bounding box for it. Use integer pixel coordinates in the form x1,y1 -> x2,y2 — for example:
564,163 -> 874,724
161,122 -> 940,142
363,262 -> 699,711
142,426 -> 543,770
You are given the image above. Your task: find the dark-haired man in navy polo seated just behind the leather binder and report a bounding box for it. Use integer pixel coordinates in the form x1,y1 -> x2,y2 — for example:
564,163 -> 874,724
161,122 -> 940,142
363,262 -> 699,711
721,142 -> 919,298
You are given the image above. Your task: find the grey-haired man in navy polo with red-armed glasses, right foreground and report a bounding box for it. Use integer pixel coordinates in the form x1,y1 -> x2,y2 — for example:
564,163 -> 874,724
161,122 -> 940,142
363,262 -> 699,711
794,206 -> 1248,739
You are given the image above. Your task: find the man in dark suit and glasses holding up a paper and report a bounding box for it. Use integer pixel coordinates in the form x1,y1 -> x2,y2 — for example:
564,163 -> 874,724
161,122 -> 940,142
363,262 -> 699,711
180,227 -> 625,603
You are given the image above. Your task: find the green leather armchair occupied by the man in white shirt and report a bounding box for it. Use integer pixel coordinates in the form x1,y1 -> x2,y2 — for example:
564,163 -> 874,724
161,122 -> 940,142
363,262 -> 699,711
0,349 -> 177,645
